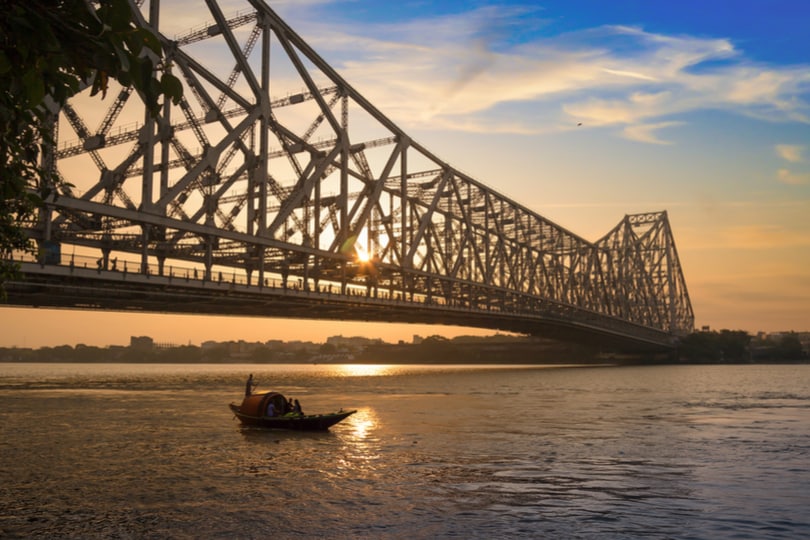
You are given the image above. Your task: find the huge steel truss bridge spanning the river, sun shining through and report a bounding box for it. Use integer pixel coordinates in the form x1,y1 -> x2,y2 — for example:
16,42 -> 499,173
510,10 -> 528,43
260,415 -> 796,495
7,0 -> 694,349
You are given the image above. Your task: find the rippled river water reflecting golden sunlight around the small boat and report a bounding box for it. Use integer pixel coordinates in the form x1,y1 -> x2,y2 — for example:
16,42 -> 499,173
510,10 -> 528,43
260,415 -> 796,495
0,364 -> 810,539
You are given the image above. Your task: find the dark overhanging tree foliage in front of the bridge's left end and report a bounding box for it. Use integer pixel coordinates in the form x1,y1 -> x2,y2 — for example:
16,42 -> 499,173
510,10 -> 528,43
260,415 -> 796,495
0,0 -> 182,292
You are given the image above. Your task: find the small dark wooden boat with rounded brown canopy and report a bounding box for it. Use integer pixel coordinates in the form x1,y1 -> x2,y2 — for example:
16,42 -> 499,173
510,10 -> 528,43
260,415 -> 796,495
229,392 -> 357,431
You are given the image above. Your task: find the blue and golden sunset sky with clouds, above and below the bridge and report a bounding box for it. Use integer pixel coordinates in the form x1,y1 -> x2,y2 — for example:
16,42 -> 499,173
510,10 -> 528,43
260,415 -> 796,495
0,0 -> 810,346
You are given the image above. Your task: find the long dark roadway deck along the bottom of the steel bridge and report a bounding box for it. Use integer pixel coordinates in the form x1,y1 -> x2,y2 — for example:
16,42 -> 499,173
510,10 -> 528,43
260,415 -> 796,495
7,262 -> 675,352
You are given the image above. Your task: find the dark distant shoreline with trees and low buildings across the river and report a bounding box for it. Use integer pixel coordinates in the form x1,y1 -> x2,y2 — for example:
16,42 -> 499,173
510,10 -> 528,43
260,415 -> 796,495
0,330 -> 810,365
